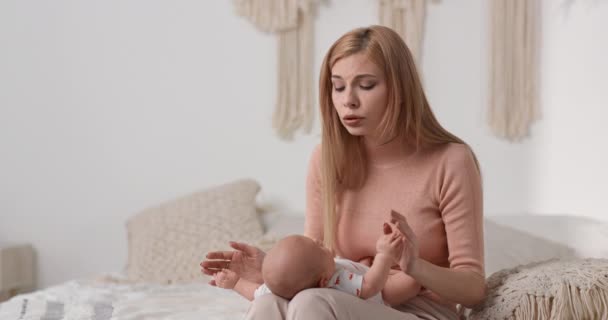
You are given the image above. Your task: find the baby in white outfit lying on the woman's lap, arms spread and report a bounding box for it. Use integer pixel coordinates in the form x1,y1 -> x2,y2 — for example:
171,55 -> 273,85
209,223 -> 405,303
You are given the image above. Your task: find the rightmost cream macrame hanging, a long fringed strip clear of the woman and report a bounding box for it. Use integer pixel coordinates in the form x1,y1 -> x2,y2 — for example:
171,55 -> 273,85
488,0 -> 541,141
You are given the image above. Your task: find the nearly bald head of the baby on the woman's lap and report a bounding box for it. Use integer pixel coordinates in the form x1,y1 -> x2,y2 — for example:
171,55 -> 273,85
262,235 -> 335,299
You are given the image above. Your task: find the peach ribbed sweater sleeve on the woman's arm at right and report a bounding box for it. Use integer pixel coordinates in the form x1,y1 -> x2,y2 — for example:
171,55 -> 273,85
438,144 -> 484,276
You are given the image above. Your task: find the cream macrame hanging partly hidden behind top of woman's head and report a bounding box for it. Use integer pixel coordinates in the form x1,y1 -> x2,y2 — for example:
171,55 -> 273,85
379,0 -> 428,67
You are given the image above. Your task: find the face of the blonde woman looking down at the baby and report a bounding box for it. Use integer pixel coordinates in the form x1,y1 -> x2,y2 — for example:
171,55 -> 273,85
331,53 -> 387,140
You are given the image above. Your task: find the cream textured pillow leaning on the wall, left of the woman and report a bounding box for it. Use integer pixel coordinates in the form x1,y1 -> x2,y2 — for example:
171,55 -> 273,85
127,180 -> 262,283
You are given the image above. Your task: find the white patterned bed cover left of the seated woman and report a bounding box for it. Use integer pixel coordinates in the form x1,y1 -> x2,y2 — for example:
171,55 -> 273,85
0,275 -> 249,320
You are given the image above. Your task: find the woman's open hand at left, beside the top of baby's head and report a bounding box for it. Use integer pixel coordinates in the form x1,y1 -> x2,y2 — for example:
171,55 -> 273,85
200,241 -> 266,284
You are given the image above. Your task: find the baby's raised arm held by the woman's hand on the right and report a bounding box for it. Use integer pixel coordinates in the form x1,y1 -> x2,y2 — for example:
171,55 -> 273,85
361,226 -> 404,299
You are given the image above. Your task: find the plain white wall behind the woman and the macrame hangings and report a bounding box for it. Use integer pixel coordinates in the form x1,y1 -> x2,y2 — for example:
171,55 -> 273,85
0,0 -> 608,287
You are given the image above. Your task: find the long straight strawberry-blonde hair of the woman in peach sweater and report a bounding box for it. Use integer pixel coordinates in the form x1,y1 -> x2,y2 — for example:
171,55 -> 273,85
319,26 -> 479,248
